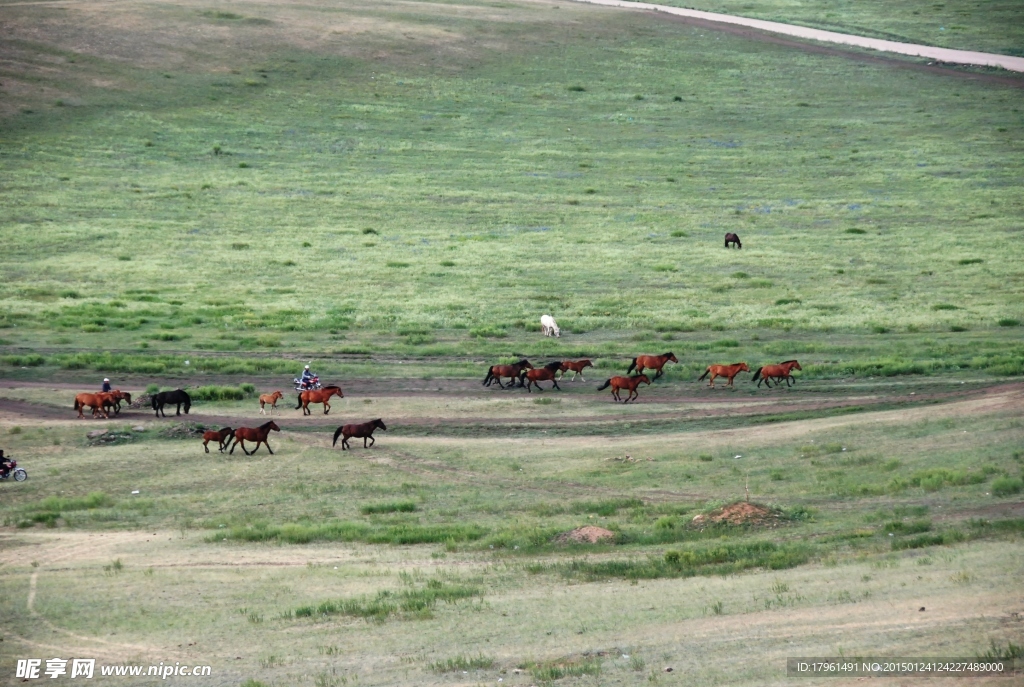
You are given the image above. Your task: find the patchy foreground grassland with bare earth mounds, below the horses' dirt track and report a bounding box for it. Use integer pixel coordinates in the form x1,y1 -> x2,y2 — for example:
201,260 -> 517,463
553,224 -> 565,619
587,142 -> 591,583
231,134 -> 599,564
0,382 -> 1024,685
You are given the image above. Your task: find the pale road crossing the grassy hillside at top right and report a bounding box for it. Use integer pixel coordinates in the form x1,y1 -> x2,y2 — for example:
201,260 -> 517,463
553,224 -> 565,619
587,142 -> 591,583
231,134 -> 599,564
572,0 -> 1024,72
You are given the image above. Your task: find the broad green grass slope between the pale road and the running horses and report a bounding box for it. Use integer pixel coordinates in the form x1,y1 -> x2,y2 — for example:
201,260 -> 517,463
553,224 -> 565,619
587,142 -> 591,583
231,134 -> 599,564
0,3 -> 1024,370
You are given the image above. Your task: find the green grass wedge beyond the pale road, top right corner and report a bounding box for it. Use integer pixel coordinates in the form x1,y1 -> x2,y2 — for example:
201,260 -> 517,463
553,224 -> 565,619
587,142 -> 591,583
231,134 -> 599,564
643,0 -> 1024,55
